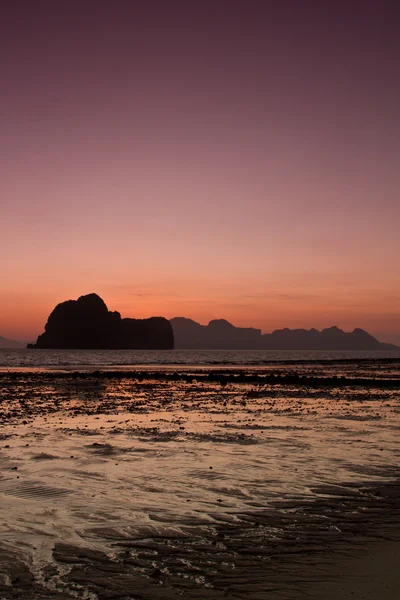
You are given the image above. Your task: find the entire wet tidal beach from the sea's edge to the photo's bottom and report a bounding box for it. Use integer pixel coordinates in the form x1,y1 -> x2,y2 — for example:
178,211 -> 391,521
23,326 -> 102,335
0,367 -> 400,600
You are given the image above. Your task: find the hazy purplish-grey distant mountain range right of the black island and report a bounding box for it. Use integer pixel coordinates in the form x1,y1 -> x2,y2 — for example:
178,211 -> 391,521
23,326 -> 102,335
170,317 -> 399,350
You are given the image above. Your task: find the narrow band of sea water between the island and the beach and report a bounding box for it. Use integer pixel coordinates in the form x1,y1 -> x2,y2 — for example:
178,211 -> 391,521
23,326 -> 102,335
0,349 -> 400,370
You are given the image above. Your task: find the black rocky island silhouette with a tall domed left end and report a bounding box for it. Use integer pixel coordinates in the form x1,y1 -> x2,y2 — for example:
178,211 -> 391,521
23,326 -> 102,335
28,294 -> 174,350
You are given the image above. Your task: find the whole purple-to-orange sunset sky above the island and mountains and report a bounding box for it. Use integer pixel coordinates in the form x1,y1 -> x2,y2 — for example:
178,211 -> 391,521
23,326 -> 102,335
0,0 -> 400,344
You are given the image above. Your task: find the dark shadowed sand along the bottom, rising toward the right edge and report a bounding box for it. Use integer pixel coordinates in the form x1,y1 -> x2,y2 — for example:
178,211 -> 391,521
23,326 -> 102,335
0,485 -> 400,600
